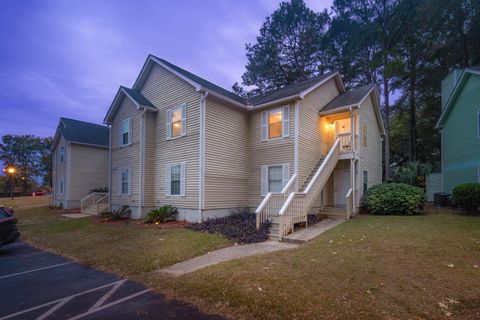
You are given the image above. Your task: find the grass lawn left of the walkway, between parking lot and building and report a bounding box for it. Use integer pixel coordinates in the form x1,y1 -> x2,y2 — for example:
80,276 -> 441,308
15,207 -> 230,279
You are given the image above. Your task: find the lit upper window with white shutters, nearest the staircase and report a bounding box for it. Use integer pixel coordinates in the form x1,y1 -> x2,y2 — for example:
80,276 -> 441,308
261,106 -> 290,140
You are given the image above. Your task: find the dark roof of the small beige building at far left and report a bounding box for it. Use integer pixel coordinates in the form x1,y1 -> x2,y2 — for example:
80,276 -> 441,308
53,118 -> 109,148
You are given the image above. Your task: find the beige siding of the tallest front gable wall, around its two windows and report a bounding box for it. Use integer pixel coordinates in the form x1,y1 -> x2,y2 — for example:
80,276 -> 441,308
141,65 -> 201,209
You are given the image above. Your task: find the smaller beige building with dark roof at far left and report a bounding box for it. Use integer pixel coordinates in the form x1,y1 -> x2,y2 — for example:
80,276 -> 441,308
52,118 -> 109,208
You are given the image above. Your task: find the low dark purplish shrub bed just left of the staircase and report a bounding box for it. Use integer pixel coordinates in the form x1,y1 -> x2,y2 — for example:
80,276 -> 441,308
189,209 -> 270,243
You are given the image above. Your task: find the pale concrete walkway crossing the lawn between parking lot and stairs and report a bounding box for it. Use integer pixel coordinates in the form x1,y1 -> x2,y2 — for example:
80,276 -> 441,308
160,241 -> 298,277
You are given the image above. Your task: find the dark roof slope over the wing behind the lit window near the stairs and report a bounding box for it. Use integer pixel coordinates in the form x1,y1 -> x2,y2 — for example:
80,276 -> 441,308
248,71 -> 343,107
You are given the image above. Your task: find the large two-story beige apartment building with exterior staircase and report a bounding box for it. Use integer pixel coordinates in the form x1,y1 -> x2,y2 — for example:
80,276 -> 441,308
99,55 -> 384,239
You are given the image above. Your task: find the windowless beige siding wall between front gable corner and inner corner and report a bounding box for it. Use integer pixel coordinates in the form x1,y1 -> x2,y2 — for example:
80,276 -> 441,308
205,98 -> 250,210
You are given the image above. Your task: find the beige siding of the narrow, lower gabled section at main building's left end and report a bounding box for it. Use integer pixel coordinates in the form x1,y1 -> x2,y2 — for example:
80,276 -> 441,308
111,97 -> 142,206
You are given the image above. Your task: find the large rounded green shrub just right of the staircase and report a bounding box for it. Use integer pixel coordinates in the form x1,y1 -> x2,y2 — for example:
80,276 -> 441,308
364,183 -> 426,215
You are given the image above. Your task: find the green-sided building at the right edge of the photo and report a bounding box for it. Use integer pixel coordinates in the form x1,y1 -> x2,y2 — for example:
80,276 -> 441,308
437,67 -> 480,193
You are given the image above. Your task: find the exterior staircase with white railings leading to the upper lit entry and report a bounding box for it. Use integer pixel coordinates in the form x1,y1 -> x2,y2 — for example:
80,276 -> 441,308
255,138 -> 353,241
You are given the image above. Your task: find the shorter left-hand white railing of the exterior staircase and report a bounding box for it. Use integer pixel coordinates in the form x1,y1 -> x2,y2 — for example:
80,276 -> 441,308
255,174 -> 297,230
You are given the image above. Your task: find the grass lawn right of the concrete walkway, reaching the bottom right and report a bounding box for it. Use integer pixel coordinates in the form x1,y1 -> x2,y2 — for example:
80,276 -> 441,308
161,211 -> 480,319
